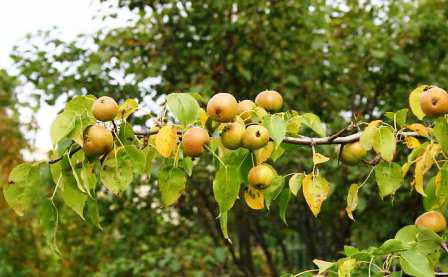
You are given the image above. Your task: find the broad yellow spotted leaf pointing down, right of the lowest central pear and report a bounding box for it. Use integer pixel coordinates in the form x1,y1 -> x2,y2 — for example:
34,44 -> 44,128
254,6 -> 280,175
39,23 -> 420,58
302,174 -> 330,217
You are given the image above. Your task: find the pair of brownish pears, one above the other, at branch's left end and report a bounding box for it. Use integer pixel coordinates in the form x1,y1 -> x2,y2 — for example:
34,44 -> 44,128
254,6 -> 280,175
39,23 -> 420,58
83,96 -> 118,156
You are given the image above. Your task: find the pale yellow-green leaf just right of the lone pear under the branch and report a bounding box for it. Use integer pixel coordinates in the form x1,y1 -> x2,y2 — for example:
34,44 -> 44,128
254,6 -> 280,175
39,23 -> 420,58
373,126 -> 397,162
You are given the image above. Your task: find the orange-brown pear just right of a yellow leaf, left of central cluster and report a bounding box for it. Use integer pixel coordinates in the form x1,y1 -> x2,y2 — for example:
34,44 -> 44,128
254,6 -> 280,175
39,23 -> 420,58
182,127 -> 210,157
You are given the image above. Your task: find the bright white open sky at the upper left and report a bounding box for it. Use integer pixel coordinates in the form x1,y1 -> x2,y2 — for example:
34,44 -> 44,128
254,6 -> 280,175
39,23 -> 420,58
0,0 -> 131,159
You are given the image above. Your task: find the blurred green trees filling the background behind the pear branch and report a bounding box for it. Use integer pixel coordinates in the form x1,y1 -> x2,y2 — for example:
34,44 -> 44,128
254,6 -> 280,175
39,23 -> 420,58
0,0 -> 448,276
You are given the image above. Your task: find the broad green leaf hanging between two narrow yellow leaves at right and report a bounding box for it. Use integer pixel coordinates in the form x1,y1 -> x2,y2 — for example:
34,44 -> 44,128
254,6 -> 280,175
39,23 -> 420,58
375,161 -> 403,199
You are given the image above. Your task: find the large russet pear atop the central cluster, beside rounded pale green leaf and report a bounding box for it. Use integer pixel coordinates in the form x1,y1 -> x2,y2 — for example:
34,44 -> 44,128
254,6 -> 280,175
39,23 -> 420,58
207,93 -> 238,122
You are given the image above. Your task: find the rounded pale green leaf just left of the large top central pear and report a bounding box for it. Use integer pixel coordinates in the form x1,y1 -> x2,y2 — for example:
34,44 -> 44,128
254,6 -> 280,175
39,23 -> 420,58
166,93 -> 199,126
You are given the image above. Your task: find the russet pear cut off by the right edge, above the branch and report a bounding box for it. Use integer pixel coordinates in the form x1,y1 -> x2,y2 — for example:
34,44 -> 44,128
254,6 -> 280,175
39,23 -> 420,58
420,86 -> 448,117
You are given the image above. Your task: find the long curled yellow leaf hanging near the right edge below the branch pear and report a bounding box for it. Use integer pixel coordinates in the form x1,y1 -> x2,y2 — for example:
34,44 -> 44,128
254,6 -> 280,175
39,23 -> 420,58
414,144 -> 441,196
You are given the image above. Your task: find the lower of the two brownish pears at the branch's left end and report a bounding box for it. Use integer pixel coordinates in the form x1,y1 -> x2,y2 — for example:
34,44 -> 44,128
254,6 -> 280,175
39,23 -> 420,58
83,125 -> 114,156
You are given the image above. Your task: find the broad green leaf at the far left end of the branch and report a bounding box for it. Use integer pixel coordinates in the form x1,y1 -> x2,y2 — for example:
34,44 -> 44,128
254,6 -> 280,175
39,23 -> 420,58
3,163 -> 51,216
